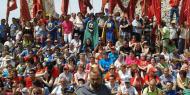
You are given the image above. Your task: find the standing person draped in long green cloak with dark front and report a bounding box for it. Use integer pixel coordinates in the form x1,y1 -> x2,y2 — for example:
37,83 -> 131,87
83,14 -> 99,49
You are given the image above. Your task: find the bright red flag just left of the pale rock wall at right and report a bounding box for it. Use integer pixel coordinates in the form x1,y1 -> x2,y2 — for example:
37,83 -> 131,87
152,0 -> 161,25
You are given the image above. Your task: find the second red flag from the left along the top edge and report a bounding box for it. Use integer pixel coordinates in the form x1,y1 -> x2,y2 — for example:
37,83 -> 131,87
20,0 -> 31,21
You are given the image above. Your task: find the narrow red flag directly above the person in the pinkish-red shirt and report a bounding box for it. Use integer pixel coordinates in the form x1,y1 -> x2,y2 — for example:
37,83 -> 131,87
61,0 -> 69,15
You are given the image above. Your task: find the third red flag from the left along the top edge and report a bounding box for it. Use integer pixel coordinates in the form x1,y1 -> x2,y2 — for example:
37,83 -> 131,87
32,0 -> 43,18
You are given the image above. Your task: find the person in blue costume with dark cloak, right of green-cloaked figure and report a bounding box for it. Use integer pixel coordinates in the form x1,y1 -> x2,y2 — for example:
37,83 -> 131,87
102,14 -> 118,43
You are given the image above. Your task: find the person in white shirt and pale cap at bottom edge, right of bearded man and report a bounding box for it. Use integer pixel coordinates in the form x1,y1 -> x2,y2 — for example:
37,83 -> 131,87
117,79 -> 139,95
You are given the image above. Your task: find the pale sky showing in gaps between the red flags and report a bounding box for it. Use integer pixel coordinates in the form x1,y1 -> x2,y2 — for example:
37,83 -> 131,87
0,0 -> 102,20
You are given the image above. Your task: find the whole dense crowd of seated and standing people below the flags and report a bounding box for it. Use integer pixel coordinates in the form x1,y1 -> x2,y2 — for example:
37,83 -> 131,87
0,5 -> 190,95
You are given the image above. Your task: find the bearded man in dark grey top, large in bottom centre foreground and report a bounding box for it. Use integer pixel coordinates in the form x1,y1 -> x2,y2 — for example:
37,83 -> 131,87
75,69 -> 111,95
